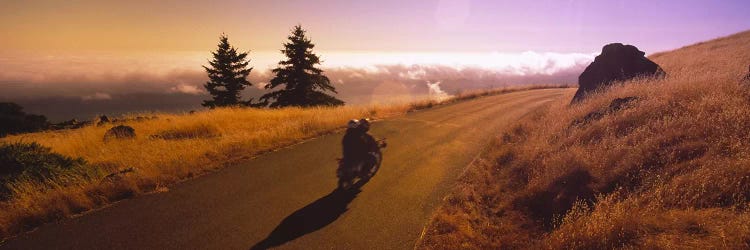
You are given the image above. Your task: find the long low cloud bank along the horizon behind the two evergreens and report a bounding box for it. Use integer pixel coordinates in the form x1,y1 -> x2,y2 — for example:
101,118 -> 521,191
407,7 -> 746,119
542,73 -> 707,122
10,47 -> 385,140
0,52 -> 594,120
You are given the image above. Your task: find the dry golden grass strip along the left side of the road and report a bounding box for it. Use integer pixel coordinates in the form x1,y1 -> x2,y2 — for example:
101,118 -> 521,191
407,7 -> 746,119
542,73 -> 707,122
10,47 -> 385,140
0,85 -> 568,239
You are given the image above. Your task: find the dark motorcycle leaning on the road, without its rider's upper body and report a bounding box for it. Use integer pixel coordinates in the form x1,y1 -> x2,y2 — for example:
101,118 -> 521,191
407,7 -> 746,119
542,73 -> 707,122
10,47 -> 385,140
336,139 -> 388,190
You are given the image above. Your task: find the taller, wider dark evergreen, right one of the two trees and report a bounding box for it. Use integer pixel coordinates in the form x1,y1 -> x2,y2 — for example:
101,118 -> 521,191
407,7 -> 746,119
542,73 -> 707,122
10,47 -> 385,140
260,25 -> 344,108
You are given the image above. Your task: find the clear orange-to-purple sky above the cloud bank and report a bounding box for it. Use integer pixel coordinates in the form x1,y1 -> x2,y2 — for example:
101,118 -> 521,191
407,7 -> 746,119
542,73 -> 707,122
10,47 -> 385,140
0,0 -> 750,52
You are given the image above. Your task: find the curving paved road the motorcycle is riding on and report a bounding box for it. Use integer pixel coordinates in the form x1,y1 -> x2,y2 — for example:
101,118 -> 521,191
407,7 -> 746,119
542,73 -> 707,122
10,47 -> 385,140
0,89 -> 575,249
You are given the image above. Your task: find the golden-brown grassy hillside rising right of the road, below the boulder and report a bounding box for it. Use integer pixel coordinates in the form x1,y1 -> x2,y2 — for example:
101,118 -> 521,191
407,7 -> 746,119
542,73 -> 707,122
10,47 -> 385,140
418,32 -> 750,249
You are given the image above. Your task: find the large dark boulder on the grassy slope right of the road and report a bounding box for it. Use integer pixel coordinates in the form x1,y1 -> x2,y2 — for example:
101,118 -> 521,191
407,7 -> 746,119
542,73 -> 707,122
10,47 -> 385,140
572,43 -> 666,103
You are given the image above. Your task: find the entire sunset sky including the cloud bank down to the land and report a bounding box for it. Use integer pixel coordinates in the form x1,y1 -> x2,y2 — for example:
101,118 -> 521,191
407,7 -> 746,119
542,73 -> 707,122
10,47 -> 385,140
0,0 -> 750,119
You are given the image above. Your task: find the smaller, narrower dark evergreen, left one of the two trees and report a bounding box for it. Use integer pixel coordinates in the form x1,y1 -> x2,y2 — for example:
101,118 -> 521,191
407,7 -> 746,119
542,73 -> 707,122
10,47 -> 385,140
202,34 -> 253,108
